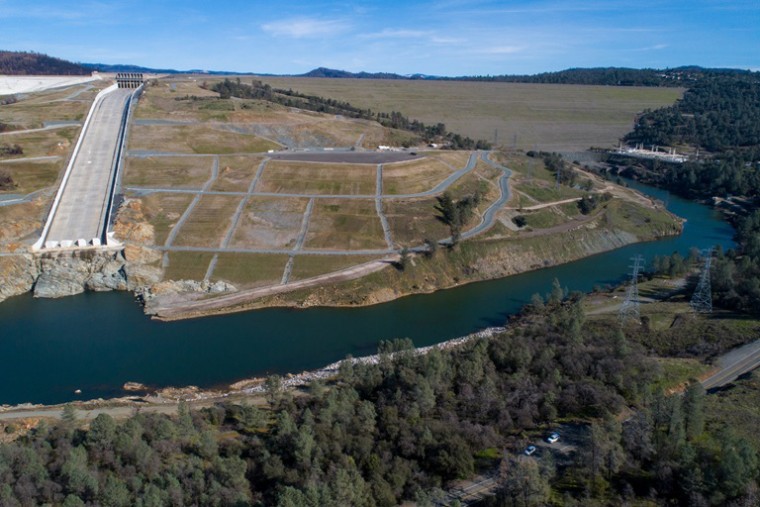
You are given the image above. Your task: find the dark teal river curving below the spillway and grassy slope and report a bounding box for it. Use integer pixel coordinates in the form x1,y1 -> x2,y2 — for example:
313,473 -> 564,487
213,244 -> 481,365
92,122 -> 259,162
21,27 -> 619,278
0,183 -> 734,404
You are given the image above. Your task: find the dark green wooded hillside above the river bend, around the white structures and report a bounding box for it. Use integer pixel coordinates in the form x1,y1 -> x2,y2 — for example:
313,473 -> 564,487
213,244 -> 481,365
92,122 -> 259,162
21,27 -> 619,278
609,73 -> 760,198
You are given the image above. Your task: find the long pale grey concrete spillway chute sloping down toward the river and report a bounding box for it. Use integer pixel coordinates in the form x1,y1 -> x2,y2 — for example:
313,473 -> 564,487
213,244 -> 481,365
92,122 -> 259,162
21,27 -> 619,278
44,89 -> 134,242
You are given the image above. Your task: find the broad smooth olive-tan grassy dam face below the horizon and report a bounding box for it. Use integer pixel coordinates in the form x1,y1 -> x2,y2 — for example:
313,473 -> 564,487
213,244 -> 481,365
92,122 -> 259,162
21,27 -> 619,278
261,77 -> 683,151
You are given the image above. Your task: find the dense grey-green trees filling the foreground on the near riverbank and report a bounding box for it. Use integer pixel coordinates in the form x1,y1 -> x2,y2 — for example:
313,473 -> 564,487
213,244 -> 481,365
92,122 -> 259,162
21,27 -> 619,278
0,292 -> 758,507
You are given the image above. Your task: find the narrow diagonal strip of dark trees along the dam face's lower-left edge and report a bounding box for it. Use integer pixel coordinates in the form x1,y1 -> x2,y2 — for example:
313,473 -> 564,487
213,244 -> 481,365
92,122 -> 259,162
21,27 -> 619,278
205,79 -> 490,150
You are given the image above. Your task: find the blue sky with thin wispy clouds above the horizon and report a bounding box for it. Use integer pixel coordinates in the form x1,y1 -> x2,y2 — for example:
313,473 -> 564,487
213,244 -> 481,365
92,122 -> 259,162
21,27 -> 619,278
0,0 -> 760,76
